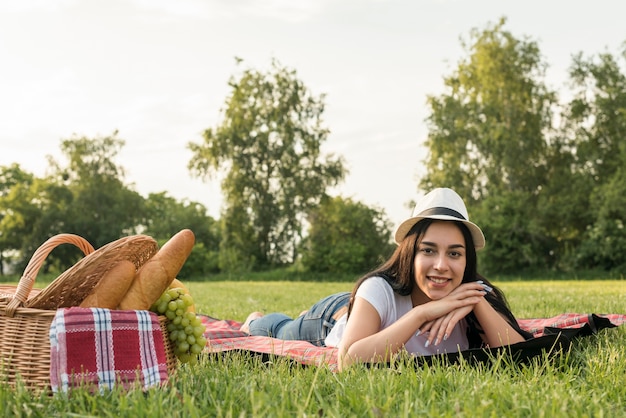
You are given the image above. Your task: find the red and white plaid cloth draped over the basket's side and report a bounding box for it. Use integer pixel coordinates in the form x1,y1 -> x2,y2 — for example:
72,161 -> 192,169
50,308 -> 168,392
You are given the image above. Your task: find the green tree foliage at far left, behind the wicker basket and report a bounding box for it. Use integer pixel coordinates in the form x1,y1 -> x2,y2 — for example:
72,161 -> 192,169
0,133 -> 202,272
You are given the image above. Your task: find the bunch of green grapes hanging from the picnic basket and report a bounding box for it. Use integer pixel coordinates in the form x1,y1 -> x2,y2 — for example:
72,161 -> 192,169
150,288 -> 206,363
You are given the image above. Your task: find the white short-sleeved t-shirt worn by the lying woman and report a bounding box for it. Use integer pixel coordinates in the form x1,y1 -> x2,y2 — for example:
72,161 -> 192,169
324,277 -> 469,356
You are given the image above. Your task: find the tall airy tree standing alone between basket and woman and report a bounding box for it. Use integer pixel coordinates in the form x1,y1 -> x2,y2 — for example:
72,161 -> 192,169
189,60 -> 345,269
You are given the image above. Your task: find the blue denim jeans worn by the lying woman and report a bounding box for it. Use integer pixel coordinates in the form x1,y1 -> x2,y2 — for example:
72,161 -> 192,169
245,292 -> 350,347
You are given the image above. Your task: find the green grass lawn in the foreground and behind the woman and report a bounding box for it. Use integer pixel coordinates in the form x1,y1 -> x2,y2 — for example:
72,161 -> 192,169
0,280 -> 626,417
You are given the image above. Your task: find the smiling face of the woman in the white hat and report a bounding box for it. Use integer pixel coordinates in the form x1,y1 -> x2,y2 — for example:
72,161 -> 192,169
414,221 -> 466,300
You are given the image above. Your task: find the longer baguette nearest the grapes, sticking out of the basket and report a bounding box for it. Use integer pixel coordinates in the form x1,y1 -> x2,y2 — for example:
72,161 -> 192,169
118,229 -> 195,310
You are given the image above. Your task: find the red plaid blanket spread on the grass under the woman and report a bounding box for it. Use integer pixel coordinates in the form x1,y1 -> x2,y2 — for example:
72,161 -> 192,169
201,313 -> 626,370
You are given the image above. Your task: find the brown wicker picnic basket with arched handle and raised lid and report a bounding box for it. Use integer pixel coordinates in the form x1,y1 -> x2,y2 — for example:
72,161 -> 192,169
0,234 -> 177,390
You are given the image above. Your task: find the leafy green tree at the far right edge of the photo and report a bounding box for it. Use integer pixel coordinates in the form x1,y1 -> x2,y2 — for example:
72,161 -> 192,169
567,43 -> 626,272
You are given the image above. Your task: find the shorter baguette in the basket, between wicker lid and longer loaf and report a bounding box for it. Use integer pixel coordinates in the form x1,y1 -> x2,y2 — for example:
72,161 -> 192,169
80,260 -> 136,309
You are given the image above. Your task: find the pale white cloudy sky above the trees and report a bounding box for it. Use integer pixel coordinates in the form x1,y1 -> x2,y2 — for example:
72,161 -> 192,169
0,0 -> 626,229
